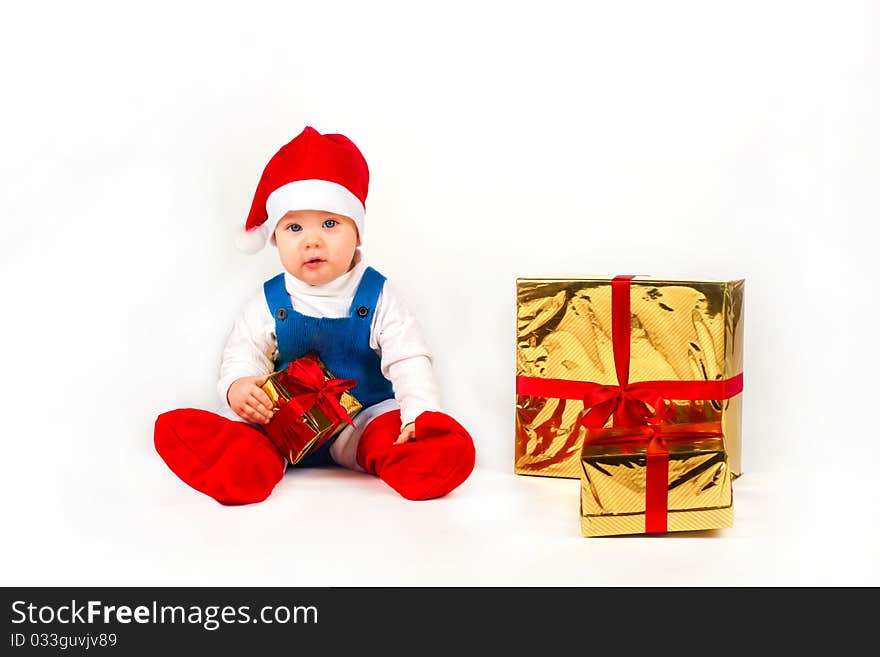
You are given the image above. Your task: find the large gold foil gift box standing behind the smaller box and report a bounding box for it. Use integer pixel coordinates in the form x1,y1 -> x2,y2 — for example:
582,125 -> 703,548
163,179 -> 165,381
514,276 -> 745,479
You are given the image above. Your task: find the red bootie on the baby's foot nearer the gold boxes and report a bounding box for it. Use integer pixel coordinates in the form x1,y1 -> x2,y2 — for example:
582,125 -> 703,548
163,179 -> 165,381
357,411 -> 475,500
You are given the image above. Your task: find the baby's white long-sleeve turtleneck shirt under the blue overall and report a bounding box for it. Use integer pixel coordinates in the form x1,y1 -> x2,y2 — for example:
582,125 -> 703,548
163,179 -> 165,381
217,251 -> 443,425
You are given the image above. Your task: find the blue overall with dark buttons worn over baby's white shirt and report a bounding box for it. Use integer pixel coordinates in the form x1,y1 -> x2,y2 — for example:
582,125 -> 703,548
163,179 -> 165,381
263,267 -> 394,467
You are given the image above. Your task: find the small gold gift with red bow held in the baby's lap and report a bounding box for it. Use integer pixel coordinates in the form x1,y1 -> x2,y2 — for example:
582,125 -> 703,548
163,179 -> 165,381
262,353 -> 362,464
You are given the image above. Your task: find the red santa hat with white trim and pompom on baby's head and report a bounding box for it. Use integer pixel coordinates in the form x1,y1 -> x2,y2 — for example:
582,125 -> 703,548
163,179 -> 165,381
236,126 -> 370,253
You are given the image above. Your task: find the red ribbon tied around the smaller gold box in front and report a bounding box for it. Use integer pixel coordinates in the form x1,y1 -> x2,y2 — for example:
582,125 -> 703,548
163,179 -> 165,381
585,420 -> 724,534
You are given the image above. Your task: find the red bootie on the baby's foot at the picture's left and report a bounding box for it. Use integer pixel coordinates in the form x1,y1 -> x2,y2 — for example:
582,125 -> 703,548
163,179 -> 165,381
153,408 -> 284,504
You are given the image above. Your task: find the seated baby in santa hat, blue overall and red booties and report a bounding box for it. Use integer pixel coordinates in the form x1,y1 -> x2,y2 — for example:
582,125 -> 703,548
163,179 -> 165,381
154,127 -> 475,504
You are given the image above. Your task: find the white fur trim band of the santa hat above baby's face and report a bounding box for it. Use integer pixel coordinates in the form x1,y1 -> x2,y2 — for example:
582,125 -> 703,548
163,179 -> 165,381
263,179 -> 366,240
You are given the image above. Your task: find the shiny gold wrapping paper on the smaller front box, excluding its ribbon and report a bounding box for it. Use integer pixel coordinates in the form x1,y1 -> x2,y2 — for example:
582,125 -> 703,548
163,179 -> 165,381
581,429 -> 733,536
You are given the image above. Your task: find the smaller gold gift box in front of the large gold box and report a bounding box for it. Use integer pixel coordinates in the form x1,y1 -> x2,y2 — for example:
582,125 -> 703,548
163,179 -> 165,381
581,423 -> 733,536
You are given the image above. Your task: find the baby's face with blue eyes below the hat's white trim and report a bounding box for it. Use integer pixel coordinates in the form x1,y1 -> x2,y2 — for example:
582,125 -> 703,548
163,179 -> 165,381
275,210 -> 360,285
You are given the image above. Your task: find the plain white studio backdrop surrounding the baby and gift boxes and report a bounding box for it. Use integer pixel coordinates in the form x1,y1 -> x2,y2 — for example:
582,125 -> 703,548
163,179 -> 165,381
0,1 -> 880,586
